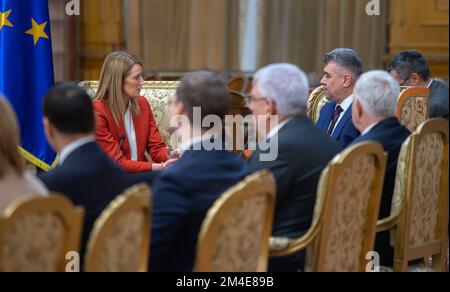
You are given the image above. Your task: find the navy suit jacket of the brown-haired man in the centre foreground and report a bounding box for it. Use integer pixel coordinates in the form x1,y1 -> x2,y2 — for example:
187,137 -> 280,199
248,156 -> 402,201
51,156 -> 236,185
149,150 -> 249,272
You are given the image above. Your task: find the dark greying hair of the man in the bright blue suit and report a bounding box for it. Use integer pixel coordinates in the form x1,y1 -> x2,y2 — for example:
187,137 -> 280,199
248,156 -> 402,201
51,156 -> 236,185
323,48 -> 363,80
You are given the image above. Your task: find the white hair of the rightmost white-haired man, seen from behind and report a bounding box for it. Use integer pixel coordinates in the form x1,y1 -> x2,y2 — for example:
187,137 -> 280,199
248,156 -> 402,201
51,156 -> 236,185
354,70 -> 400,118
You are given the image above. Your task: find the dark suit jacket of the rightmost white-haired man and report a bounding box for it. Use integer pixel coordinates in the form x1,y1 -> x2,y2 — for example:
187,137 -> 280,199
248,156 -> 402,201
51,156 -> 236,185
352,118 -> 410,266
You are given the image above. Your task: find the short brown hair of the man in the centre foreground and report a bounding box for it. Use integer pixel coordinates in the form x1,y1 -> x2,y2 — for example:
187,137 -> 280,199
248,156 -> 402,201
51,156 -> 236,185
177,71 -> 230,123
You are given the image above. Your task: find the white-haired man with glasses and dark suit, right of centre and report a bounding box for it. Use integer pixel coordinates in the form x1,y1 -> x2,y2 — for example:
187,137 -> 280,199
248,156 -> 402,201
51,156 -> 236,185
247,64 -> 341,271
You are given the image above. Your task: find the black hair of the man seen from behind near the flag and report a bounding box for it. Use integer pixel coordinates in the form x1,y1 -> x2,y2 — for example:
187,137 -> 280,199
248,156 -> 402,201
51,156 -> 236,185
44,83 -> 95,134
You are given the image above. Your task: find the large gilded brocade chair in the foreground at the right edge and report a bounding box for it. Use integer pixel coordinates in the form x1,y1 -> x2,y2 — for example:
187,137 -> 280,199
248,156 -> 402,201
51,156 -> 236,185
377,119 -> 449,271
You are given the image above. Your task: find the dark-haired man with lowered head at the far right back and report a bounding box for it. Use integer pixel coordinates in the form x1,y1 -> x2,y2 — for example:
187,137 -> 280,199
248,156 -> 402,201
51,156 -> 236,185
387,50 -> 449,120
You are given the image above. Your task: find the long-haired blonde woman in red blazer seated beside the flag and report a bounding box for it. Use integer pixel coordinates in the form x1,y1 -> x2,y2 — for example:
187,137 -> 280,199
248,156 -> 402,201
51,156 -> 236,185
94,52 -> 174,172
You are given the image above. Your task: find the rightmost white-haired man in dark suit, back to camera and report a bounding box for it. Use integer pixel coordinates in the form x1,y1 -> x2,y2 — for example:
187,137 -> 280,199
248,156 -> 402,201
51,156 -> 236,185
352,71 -> 410,266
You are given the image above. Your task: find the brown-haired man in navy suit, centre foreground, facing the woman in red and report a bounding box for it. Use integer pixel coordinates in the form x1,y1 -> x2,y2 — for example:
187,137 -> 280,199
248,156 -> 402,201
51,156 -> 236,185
149,71 -> 248,272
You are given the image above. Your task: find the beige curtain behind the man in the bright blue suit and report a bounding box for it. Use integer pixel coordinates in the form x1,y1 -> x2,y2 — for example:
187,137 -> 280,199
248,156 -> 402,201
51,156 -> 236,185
259,0 -> 388,72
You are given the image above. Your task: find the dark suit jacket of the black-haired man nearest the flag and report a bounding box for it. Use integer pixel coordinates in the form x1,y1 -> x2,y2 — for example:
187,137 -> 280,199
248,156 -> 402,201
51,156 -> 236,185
39,142 -> 128,259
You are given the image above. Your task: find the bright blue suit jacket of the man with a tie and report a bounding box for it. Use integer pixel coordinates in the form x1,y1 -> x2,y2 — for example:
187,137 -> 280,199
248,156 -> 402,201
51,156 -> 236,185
317,101 -> 360,148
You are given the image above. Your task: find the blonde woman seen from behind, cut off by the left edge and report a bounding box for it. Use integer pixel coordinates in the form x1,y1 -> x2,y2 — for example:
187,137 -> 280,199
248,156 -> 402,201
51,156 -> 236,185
0,96 -> 48,214
